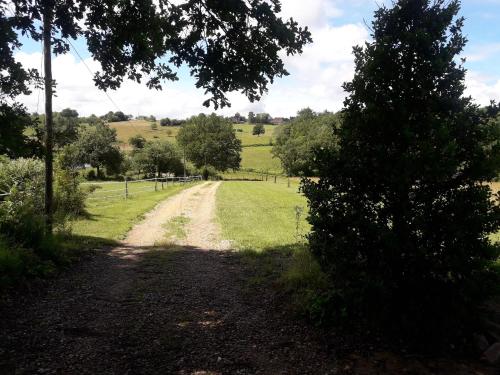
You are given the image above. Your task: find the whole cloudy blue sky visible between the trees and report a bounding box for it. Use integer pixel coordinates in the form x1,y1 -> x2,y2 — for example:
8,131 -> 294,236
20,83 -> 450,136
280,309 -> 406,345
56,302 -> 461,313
10,0 -> 500,118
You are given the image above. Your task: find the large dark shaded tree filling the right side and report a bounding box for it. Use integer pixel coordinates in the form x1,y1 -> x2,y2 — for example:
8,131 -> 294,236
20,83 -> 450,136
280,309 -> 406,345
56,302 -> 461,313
303,0 -> 500,348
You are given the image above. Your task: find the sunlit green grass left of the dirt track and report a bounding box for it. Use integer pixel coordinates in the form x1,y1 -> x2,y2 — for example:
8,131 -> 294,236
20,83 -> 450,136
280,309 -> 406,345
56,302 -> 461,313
72,182 -> 197,240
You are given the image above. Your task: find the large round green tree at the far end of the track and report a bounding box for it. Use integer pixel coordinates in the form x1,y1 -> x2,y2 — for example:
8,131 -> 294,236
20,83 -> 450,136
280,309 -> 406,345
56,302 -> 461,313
177,114 -> 241,172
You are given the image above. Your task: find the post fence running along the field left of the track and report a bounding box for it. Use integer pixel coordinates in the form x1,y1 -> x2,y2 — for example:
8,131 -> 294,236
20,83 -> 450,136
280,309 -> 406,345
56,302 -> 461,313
81,176 -> 202,200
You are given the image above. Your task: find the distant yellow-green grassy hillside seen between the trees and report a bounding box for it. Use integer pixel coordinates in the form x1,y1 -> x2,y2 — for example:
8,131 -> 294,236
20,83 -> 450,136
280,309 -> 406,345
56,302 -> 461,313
109,120 -> 281,173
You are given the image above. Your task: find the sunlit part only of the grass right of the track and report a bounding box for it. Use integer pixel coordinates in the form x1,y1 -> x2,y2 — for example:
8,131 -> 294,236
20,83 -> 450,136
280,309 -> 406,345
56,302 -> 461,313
217,181 -> 309,251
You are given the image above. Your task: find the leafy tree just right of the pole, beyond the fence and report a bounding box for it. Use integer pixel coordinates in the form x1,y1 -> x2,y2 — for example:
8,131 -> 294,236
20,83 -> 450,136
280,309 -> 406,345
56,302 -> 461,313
76,124 -> 123,176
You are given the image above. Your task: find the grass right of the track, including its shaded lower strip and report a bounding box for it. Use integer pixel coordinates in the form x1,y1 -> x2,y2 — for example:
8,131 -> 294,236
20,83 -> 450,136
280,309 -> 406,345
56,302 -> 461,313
217,180 -> 329,321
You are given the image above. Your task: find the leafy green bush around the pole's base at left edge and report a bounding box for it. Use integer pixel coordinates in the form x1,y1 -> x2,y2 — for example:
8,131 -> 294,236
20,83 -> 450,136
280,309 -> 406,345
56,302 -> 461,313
0,154 -> 85,287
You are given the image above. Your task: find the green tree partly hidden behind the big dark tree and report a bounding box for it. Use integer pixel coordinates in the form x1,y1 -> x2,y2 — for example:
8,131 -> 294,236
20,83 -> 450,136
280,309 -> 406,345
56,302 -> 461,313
272,108 -> 339,176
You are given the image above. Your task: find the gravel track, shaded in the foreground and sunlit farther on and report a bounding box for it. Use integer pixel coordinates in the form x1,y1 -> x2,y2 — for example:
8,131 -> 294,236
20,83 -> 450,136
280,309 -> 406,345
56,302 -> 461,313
0,183 -> 494,375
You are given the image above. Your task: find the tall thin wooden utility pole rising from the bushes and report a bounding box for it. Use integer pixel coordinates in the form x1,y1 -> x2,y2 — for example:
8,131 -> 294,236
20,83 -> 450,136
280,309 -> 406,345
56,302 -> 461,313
43,4 -> 54,233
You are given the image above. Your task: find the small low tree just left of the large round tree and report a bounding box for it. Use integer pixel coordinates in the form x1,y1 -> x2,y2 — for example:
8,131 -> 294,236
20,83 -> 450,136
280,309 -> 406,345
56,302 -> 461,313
133,141 -> 183,177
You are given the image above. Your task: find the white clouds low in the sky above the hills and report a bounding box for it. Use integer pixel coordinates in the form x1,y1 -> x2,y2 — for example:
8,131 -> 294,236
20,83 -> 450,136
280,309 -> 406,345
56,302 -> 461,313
16,0 -> 500,118
